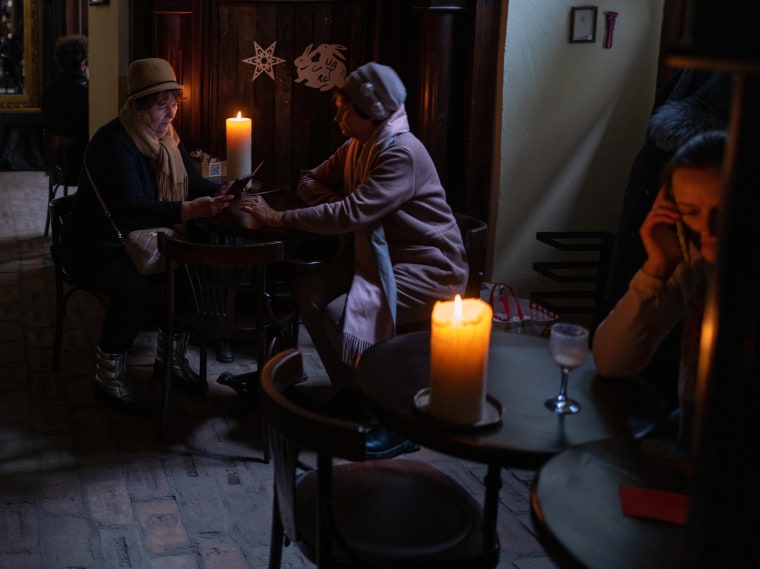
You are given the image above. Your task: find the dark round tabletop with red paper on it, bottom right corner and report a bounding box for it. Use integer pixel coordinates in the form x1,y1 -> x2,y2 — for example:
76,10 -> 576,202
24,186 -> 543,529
531,439 -> 689,569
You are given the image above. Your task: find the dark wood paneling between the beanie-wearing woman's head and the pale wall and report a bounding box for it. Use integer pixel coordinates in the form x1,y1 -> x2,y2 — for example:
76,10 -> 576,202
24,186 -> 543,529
372,0 -> 506,220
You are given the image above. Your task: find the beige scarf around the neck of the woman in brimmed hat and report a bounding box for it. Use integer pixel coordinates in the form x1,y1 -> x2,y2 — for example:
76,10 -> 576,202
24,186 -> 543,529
119,103 -> 189,202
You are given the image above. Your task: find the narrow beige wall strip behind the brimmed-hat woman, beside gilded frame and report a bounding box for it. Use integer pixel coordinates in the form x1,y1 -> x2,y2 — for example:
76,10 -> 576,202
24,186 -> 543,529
87,0 -> 130,137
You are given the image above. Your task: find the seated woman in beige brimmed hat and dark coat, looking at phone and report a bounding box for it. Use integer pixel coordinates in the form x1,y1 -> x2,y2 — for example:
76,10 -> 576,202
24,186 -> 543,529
64,58 -> 232,412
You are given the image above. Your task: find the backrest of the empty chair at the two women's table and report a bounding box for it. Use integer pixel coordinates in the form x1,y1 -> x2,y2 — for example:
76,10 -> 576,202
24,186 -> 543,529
158,233 -> 285,340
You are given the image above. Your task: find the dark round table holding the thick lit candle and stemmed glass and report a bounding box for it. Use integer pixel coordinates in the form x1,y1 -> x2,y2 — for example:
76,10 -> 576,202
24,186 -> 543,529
357,328 -> 665,468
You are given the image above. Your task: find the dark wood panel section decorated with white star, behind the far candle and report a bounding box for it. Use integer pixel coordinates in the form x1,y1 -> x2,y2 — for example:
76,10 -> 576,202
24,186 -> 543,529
202,1 -> 366,181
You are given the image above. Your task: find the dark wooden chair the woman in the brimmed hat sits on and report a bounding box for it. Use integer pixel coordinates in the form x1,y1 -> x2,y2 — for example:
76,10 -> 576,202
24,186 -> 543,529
48,195 -> 107,371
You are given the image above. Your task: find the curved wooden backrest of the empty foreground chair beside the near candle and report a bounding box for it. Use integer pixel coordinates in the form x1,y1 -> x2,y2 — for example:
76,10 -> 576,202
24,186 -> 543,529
260,348 -> 369,541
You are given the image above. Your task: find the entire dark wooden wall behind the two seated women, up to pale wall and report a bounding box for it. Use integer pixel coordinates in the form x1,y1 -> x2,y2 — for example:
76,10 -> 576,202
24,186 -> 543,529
133,0 -> 504,219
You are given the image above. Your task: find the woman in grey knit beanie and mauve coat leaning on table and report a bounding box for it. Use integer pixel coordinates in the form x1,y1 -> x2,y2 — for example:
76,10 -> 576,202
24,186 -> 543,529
241,62 -> 468,458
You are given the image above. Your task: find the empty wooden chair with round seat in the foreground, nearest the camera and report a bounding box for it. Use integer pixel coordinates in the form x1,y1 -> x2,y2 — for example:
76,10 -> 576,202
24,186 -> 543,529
261,349 -> 499,569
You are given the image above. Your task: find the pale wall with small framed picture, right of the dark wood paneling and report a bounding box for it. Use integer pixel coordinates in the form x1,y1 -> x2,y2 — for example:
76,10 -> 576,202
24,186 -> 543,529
489,0 -> 663,296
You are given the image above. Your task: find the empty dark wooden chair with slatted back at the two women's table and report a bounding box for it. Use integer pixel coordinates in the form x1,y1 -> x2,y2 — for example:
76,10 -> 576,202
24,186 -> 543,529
158,233 -> 287,435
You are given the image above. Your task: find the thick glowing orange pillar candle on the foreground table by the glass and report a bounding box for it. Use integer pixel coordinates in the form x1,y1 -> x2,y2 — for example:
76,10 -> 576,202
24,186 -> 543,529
428,295 -> 493,425
